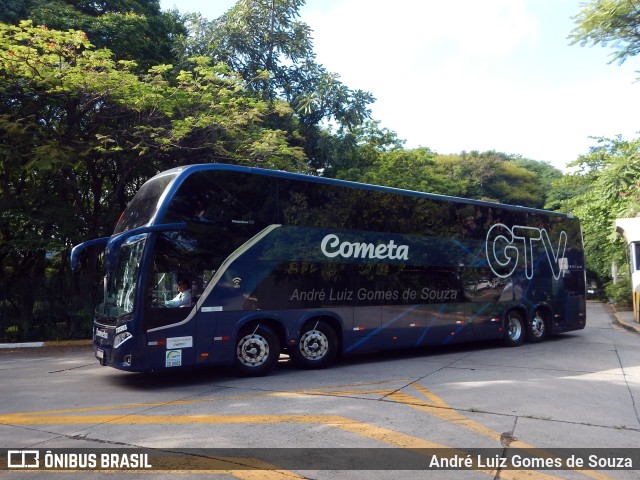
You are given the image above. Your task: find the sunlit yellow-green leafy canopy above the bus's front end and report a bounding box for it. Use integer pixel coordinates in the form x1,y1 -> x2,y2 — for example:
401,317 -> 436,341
0,22 -> 305,237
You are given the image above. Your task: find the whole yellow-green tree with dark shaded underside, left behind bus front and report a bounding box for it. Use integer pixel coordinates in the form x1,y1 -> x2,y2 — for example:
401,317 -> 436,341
0,21 -> 306,338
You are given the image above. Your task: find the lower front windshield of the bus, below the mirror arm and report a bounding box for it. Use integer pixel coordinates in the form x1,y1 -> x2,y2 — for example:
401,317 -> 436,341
97,235 -> 147,320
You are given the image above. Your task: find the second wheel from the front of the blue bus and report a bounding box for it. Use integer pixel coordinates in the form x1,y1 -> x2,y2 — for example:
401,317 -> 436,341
290,320 -> 338,368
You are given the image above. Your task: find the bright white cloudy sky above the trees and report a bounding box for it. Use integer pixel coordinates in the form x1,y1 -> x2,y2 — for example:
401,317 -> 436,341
160,0 -> 640,171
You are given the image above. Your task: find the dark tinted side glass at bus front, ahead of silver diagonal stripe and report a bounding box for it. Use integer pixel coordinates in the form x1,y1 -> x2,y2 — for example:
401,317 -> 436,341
148,171 -> 276,326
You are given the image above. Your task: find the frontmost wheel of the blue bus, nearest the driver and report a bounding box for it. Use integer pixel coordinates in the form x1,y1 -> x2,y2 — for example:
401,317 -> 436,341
233,325 -> 280,377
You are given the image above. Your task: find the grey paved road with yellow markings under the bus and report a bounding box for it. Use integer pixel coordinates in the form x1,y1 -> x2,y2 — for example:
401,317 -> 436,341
0,303 -> 640,480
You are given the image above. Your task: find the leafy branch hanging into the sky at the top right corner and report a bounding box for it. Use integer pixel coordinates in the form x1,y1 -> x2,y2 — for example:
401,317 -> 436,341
569,0 -> 640,63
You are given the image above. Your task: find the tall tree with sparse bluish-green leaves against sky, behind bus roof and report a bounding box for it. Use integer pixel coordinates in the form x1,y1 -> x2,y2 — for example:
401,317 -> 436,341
181,0 -> 374,172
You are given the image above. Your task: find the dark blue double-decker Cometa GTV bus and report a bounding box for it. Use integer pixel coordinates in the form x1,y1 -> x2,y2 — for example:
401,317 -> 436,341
71,164 -> 586,375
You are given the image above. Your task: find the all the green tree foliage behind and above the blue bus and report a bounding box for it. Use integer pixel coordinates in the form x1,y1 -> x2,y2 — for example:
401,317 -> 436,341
0,0 -> 640,342
